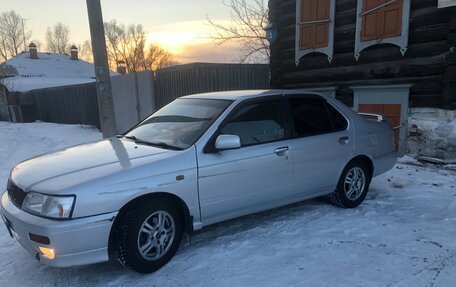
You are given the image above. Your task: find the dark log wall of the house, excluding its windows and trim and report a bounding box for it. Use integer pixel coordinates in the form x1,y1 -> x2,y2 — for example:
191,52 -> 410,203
269,0 -> 456,109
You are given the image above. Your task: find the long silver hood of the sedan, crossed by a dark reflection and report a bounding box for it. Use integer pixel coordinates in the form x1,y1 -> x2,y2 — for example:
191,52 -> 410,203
11,138 -> 177,194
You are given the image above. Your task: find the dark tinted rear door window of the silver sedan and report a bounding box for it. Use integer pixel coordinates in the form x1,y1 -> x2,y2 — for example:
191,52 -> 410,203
288,97 -> 333,137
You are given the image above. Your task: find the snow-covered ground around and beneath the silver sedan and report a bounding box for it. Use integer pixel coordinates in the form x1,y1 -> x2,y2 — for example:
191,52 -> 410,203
0,122 -> 456,286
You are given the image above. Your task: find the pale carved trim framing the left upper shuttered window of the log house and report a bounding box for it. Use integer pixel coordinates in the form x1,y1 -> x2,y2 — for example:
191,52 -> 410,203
295,0 -> 336,66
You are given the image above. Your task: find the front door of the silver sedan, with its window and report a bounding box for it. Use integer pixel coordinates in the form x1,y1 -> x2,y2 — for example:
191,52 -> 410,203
198,96 -> 293,224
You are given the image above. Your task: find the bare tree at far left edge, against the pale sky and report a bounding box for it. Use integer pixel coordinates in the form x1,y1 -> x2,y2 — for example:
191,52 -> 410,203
0,10 -> 32,60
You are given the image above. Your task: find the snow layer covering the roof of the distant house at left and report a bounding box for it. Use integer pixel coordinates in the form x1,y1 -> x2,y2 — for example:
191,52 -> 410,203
2,52 -> 117,92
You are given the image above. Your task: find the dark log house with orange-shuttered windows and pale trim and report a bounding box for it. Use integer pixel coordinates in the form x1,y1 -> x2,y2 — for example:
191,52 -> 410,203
269,0 -> 456,153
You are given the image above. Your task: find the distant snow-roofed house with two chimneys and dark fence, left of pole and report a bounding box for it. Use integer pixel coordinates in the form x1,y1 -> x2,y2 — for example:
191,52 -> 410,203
0,43 -> 117,126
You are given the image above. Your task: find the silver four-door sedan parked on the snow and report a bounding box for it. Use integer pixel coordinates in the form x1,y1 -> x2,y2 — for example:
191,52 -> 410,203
0,90 -> 396,273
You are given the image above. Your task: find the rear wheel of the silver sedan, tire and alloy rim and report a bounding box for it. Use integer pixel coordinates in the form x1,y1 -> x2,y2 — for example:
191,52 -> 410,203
328,160 -> 372,208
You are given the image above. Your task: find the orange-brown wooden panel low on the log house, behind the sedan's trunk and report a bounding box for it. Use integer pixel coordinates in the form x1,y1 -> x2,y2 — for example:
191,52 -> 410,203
358,104 -> 401,151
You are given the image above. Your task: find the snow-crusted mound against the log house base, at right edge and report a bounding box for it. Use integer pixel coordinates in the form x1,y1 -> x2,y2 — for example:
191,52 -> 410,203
408,108 -> 456,164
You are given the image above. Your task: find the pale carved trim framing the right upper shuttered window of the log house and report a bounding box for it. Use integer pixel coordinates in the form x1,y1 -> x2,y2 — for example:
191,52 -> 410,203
355,0 -> 410,61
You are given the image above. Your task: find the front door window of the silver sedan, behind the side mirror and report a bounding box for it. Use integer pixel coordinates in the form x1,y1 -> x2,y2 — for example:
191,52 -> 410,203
220,100 -> 285,146
